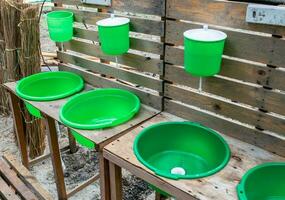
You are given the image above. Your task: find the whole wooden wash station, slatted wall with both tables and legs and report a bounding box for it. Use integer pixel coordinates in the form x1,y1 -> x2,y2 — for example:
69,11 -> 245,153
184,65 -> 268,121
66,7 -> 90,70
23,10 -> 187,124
6,0 -> 285,200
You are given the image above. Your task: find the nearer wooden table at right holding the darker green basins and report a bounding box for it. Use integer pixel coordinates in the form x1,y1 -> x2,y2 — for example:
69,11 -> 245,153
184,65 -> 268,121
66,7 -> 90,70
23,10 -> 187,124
103,113 -> 285,200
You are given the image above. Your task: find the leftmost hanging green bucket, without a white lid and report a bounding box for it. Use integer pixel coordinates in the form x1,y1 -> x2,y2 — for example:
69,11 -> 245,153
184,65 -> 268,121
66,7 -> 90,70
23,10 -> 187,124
47,10 -> 73,42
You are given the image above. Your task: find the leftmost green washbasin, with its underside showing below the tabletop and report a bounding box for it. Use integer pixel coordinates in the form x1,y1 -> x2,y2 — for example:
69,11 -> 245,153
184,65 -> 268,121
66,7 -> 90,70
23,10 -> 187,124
16,72 -> 84,118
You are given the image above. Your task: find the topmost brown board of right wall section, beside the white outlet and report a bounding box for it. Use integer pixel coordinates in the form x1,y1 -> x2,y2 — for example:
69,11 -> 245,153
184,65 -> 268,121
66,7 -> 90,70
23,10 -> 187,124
166,0 -> 285,35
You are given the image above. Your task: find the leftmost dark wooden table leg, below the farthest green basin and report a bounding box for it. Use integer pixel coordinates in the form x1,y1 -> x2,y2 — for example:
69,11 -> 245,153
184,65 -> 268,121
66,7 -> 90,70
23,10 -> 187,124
10,93 -> 29,168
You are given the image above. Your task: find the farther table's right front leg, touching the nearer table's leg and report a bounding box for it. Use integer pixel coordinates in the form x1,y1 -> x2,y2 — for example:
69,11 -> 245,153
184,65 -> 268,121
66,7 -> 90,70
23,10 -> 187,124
99,150 -> 111,200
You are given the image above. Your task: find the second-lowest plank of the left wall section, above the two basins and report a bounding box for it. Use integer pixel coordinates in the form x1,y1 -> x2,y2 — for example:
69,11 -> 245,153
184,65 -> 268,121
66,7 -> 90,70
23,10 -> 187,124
57,52 -> 163,92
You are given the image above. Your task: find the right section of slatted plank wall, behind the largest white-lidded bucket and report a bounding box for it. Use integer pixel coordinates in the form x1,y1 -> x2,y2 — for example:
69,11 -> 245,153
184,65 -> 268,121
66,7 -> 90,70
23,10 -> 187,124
164,0 -> 285,156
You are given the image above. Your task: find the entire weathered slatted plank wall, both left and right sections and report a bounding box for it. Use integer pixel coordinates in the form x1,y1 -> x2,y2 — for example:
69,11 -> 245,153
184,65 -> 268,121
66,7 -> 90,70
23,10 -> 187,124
55,0 -> 285,156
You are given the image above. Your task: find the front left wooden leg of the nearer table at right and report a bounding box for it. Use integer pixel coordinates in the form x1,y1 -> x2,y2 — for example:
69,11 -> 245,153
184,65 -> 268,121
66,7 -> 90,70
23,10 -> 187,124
109,161 -> 123,200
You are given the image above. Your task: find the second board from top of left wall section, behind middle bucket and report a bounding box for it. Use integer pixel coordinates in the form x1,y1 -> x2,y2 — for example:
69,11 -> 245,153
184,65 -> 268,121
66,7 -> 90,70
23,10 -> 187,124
54,7 -> 164,36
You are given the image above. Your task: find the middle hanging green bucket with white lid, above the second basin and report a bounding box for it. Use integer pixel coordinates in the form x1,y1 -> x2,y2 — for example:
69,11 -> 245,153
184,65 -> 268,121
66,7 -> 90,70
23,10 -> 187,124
97,16 -> 130,55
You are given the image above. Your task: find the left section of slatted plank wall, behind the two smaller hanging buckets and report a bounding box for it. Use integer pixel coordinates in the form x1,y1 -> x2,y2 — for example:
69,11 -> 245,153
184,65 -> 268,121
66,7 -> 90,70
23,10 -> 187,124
54,0 -> 165,110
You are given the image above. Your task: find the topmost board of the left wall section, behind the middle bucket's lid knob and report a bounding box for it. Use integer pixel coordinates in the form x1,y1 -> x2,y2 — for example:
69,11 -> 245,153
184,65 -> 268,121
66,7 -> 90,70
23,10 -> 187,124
61,0 -> 165,16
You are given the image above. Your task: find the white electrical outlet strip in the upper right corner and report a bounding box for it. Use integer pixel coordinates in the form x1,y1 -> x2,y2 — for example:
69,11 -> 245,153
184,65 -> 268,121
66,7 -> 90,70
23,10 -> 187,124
246,4 -> 285,26
